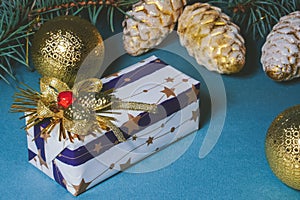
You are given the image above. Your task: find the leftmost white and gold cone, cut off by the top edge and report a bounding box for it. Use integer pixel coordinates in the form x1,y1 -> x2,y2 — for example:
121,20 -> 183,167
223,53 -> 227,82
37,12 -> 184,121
123,0 -> 186,56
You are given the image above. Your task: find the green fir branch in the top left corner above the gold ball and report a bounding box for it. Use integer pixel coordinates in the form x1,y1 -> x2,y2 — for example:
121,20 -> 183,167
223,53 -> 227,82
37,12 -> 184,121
0,0 -> 138,84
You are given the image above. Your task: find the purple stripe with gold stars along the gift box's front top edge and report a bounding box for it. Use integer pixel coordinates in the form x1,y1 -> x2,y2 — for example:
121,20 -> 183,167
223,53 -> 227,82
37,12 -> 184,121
57,83 -> 200,166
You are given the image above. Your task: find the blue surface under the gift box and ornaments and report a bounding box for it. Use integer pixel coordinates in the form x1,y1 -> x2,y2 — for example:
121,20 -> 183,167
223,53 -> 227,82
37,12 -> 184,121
0,8 -> 300,199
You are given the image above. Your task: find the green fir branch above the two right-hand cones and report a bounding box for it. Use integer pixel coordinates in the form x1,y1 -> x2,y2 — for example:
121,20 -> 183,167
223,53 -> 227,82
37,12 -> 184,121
208,0 -> 297,39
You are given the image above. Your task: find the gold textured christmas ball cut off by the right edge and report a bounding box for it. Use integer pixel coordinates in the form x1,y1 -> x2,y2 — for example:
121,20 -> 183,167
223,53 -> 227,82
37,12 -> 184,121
265,105 -> 300,190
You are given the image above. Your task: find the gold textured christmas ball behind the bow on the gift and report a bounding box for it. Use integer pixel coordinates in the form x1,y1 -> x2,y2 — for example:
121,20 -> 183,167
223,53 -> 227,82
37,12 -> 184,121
31,16 -> 104,86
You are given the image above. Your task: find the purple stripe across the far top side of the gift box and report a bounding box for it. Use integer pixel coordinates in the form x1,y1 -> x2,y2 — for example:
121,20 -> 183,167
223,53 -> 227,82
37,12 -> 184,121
103,59 -> 167,91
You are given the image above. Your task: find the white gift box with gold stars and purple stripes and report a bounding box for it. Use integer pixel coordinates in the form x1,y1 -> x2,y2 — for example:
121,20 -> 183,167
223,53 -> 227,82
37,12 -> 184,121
27,56 -> 200,196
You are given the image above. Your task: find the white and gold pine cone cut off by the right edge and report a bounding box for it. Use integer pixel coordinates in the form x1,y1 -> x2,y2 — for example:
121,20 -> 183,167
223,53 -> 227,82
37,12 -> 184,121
261,11 -> 300,81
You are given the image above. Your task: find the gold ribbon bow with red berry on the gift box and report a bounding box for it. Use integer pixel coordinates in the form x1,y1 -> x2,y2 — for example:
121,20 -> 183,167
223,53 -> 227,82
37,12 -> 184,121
11,77 -> 157,142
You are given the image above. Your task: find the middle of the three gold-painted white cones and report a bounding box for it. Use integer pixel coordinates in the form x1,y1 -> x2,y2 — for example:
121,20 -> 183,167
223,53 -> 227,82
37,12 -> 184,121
177,3 -> 246,74
